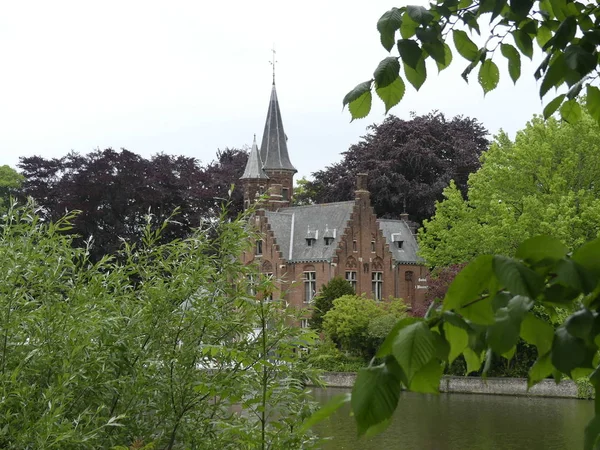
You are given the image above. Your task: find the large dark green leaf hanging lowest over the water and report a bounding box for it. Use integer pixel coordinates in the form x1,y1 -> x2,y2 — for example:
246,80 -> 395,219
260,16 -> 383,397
351,363 -> 401,436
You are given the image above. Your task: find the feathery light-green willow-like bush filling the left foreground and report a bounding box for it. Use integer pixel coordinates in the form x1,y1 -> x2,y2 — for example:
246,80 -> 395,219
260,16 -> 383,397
0,205 -> 316,449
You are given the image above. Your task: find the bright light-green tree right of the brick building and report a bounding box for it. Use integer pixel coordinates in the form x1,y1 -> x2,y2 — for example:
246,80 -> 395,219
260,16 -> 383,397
419,113 -> 600,267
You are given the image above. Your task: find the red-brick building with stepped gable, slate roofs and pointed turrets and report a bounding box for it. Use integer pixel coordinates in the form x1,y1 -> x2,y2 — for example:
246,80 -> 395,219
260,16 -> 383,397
241,83 -> 427,325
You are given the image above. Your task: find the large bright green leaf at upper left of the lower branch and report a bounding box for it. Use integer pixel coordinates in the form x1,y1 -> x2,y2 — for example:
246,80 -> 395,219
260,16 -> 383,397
443,255 -> 495,310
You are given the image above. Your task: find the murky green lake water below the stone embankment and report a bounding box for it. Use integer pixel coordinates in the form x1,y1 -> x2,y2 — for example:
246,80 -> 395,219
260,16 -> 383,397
313,388 -> 594,450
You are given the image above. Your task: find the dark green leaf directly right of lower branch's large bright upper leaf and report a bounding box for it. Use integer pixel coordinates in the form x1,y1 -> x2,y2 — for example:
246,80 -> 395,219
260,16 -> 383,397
493,256 -> 544,298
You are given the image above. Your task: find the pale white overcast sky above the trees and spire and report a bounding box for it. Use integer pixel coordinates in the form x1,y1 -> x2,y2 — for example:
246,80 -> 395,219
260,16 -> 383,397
0,0 -> 542,176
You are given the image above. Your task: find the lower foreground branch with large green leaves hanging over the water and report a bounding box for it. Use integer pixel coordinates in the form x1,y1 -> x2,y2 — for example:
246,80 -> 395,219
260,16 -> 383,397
305,236 -> 600,450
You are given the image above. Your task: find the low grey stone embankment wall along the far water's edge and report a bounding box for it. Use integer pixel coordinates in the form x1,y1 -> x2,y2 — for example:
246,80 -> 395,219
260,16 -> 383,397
322,372 -> 577,398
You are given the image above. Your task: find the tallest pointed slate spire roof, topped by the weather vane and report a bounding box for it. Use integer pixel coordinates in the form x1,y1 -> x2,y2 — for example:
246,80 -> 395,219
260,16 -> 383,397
260,82 -> 297,173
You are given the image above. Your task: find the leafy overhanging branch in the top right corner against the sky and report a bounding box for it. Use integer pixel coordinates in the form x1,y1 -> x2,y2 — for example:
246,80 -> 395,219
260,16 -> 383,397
343,0 -> 600,122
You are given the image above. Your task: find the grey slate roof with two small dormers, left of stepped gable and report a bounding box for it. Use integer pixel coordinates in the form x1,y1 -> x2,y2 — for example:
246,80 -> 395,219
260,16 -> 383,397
265,201 -> 354,262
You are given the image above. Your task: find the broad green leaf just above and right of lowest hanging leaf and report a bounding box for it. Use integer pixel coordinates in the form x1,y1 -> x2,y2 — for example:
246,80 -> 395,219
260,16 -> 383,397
392,322 -> 436,384
